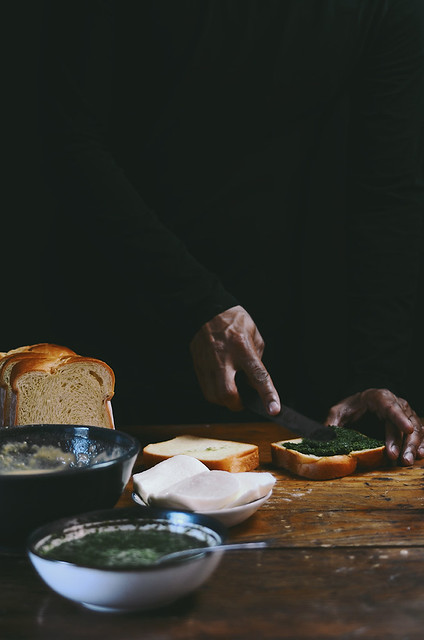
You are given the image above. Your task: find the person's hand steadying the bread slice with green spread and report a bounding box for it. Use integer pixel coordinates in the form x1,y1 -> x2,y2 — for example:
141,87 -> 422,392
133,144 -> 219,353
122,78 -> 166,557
325,389 -> 424,466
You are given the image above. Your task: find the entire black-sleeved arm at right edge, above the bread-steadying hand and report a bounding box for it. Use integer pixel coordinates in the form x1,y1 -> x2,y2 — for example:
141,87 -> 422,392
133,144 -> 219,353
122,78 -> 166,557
347,0 -> 424,392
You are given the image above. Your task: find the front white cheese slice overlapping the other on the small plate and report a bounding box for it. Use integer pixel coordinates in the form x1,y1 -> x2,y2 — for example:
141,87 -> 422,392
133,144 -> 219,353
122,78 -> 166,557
150,470 -> 240,511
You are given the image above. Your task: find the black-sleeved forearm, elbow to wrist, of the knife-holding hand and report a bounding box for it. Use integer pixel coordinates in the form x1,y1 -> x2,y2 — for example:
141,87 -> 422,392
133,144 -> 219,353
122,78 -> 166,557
44,138 -> 237,342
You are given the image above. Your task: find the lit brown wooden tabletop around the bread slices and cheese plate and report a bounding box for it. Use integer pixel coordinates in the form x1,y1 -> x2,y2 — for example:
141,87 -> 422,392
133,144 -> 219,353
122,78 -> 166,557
120,423 -> 424,547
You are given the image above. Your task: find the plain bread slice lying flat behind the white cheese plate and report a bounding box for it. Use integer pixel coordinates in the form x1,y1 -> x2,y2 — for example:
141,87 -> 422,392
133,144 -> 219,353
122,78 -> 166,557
142,435 -> 259,472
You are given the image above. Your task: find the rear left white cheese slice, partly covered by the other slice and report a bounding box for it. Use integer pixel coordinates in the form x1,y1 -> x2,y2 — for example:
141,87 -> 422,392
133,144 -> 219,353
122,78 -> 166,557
133,455 -> 209,504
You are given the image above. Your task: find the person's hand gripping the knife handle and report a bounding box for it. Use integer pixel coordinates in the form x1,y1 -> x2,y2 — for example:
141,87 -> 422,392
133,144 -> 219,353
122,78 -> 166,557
190,305 -> 281,415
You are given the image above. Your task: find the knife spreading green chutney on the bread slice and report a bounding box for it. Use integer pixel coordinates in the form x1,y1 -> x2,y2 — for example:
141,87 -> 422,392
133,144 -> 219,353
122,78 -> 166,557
235,371 -> 336,441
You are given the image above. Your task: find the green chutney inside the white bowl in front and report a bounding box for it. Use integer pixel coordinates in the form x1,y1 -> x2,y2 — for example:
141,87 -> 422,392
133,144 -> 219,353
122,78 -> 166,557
39,528 -> 207,569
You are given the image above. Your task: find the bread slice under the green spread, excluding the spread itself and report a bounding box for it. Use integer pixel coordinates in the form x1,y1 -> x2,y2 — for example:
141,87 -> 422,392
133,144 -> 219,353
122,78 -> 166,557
271,428 -> 386,480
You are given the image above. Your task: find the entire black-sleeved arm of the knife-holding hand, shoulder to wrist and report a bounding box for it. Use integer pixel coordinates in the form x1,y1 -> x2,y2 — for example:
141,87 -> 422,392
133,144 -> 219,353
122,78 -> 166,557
40,2 -> 237,341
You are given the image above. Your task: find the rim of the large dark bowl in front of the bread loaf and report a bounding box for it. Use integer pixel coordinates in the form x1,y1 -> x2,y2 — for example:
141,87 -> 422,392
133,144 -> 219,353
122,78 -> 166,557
0,424 -> 140,484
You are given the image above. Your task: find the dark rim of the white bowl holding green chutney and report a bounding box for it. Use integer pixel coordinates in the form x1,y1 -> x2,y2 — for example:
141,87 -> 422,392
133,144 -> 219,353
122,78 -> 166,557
27,506 -> 228,573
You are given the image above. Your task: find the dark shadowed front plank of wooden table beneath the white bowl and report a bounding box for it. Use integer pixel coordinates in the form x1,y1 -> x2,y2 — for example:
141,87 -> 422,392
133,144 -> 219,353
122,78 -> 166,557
0,547 -> 424,640
